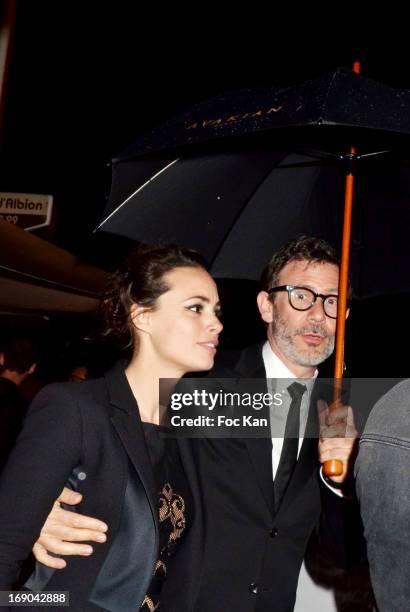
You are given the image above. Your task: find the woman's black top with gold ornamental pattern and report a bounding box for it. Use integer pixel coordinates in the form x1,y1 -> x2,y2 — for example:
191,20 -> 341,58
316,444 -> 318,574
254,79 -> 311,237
140,423 -> 193,612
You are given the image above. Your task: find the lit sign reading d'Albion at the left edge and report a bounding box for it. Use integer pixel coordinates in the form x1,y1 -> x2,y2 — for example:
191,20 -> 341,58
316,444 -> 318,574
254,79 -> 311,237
0,191 -> 53,230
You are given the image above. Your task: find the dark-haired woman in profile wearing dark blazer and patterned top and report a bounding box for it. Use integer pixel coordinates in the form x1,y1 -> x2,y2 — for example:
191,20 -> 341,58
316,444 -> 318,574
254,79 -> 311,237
0,246 -> 222,612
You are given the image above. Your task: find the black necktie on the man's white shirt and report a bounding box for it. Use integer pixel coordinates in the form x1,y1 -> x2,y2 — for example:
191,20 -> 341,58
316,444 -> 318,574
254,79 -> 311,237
274,382 -> 306,512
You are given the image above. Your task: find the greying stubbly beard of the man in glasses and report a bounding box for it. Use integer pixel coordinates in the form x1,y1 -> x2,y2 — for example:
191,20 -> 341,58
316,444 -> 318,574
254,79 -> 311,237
272,305 -> 335,367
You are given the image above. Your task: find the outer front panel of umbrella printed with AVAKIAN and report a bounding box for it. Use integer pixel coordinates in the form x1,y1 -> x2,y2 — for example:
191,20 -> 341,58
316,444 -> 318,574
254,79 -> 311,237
109,68 -> 410,158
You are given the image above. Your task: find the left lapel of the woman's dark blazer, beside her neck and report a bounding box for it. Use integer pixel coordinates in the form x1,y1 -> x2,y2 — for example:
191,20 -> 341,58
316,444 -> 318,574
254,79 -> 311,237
105,363 -> 158,529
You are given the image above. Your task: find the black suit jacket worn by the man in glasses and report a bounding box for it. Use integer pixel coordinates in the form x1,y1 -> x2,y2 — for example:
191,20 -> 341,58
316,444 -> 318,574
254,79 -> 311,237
195,344 -> 351,612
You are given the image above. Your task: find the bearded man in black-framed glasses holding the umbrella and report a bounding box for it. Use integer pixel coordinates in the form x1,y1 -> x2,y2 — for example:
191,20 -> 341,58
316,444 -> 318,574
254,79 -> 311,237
31,237 -> 355,612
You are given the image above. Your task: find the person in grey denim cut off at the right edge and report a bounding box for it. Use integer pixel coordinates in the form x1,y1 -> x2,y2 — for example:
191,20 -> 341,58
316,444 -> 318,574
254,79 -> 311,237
355,380 -> 410,612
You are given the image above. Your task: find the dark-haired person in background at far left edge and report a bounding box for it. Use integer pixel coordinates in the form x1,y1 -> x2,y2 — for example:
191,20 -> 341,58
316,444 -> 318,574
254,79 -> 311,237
0,339 -> 37,471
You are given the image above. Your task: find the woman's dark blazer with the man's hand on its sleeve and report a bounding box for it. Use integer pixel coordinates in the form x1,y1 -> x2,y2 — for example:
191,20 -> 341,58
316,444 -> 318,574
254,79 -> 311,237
0,365 -> 203,612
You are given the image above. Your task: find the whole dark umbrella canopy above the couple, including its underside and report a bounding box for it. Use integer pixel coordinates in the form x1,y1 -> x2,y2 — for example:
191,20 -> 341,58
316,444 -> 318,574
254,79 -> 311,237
99,69 -> 410,295
